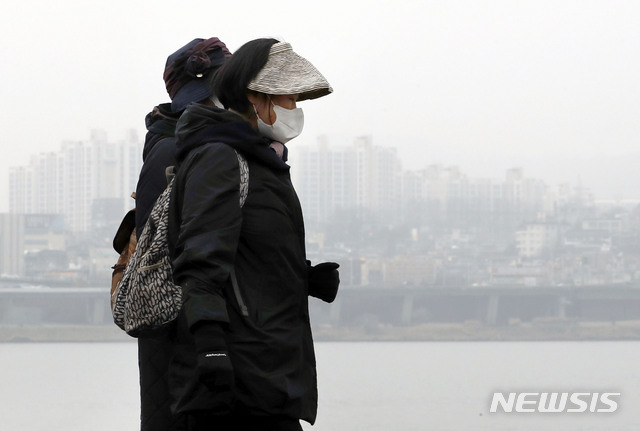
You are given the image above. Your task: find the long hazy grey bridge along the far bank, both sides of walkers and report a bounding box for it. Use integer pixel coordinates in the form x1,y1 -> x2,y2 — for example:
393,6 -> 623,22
0,285 -> 640,325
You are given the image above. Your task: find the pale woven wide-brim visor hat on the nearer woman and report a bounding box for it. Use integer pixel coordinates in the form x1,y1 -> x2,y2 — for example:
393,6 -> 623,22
247,42 -> 333,101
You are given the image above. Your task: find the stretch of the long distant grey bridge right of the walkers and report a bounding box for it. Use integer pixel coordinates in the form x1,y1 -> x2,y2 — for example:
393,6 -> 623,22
312,285 -> 640,325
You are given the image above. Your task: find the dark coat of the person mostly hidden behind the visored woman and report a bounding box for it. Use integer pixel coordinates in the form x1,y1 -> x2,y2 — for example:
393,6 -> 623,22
136,103 -> 184,431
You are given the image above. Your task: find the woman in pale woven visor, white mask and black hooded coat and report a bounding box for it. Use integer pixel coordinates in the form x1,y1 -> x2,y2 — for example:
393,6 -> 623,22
169,39 -> 339,431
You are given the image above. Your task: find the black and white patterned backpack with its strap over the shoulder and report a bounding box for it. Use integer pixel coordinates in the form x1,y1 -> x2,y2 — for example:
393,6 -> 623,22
111,152 -> 249,337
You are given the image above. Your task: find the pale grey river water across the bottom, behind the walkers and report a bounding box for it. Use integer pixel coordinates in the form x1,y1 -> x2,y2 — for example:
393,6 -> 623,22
0,342 -> 640,431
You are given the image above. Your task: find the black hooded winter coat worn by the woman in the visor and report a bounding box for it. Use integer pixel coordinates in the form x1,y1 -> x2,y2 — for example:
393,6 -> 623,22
169,104 -> 317,429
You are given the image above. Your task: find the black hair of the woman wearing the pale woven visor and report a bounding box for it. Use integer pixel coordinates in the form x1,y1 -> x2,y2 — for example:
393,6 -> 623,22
213,39 -> 278,114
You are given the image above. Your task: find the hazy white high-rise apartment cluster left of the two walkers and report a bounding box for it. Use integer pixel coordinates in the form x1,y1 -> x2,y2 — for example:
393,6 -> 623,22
9,130 -> 142,233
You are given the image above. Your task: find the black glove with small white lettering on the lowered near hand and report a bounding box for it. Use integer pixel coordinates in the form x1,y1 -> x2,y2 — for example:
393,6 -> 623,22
193,322 -> 234,401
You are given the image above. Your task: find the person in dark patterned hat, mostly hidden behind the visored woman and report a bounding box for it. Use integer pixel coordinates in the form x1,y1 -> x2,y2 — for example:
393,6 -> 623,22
136,37 -> 231,431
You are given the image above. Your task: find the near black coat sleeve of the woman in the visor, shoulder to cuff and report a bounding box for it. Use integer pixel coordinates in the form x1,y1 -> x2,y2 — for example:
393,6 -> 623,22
173,143 -> 242,329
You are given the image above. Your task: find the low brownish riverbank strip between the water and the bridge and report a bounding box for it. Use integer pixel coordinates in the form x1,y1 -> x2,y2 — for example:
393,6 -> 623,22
0,320 -> 640,342
